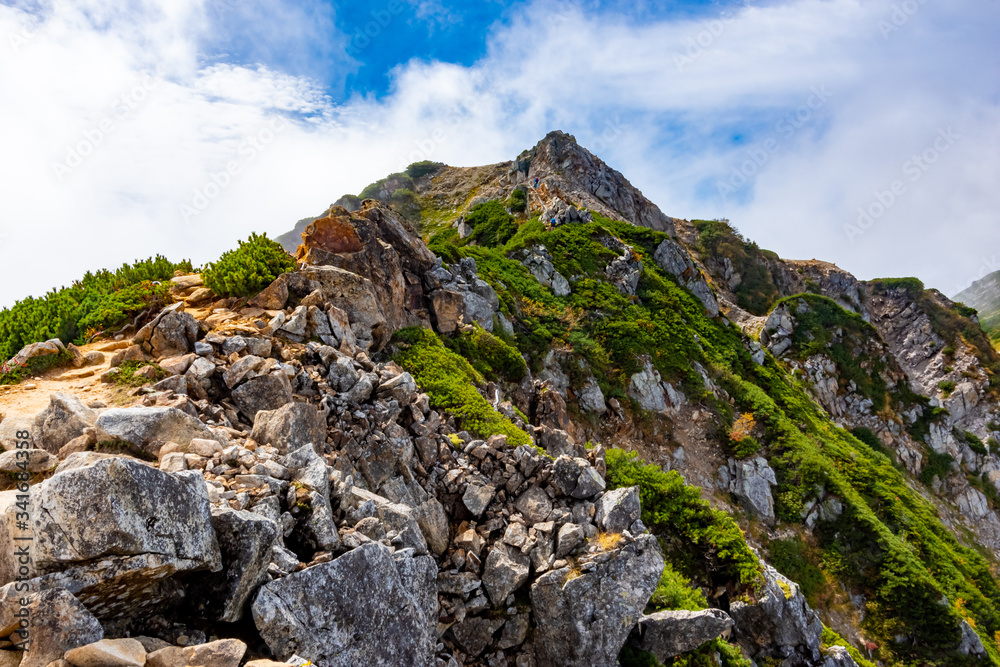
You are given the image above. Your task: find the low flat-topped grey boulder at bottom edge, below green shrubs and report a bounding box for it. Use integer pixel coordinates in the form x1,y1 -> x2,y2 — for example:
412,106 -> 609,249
629,609 -> 733,662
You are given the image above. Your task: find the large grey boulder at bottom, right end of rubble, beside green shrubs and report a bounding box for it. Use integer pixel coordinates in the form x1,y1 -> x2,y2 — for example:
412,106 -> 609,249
531,535 -> 663,667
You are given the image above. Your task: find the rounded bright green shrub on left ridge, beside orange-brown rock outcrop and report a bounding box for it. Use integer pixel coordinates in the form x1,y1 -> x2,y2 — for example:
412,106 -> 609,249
201,234 -> 295,297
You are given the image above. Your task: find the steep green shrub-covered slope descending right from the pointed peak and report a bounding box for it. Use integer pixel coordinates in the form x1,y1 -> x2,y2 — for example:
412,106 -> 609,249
282,133 -> 1000,660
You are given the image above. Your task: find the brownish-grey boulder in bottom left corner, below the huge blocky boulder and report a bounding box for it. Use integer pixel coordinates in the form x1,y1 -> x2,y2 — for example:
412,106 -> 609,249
0,583 -> 104,667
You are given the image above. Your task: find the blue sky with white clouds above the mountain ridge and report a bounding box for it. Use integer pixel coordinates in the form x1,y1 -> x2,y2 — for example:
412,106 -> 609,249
0,0 -> 1000,305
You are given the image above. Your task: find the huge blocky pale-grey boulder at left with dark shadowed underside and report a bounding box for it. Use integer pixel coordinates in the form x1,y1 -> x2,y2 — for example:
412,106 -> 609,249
0,458 -> 221,618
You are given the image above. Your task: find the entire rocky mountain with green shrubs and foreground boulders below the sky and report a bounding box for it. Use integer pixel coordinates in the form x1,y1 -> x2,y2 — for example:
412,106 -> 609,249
0,132 -> 1000,667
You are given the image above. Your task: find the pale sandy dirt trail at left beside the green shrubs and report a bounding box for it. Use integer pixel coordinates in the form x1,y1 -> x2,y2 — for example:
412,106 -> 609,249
0,340 -> 131,417
